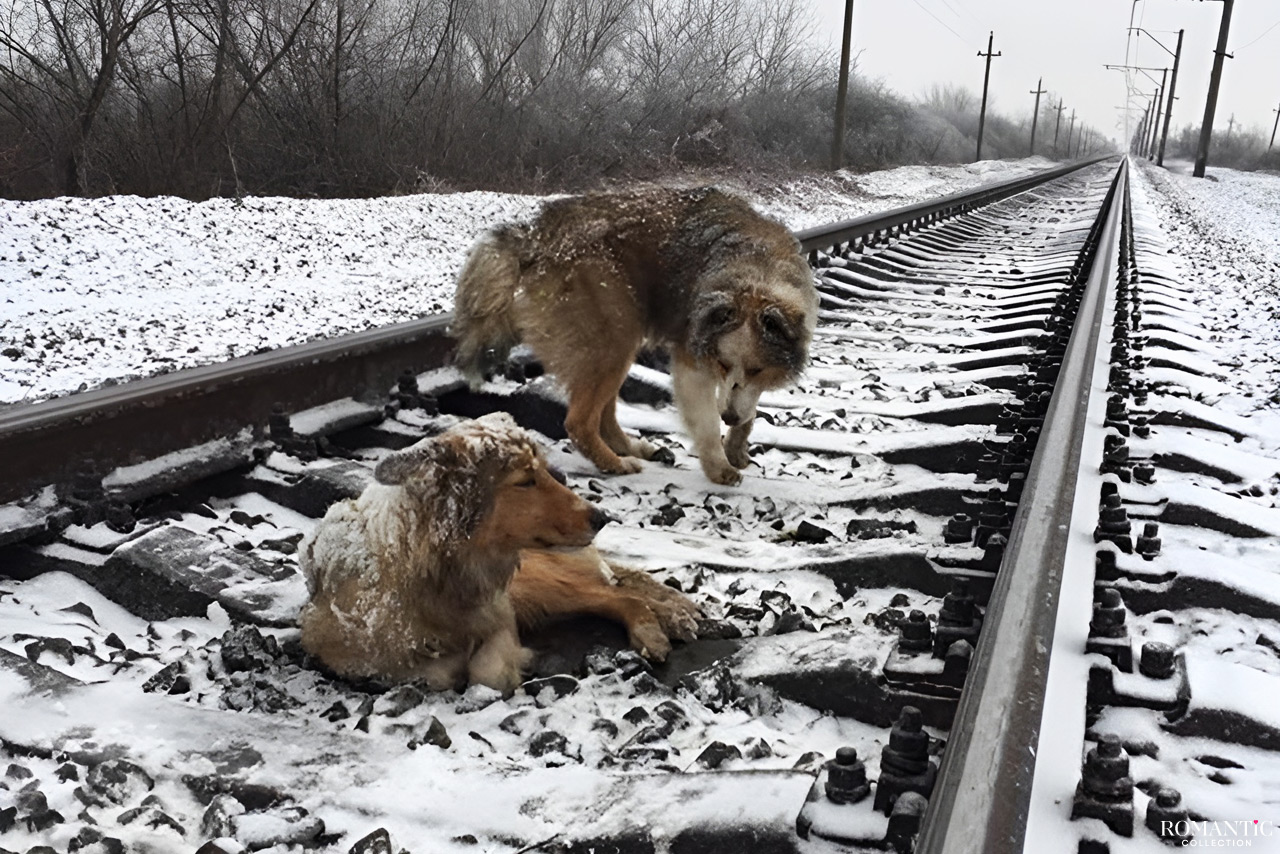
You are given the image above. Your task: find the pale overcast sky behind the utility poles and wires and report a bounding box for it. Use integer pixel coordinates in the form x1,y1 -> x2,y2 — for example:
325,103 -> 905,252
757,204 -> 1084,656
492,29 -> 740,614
809,0 -> 1280,150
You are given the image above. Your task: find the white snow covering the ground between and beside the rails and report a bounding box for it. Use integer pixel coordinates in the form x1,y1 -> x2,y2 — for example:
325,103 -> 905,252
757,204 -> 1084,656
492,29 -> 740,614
0,159 -> 1280,854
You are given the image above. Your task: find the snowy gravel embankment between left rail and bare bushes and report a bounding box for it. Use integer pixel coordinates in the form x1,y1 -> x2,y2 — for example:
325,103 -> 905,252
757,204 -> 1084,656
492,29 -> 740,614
0,157 -> 1052,403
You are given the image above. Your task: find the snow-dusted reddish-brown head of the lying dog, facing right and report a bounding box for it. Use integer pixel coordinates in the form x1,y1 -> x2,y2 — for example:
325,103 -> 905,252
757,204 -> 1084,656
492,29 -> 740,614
374,412 -> 609,554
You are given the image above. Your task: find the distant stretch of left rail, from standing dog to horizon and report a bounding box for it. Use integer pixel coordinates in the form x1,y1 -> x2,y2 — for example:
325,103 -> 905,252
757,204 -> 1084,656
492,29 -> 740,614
796,155 -> 1116,256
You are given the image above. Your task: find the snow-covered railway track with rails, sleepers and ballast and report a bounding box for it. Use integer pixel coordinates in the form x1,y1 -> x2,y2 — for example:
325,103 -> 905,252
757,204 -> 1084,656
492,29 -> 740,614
0,160 -> 1280,854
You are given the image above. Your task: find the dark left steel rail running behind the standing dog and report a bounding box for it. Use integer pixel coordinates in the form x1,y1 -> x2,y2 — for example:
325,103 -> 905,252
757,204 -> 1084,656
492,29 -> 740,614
0,157 -> 1106,502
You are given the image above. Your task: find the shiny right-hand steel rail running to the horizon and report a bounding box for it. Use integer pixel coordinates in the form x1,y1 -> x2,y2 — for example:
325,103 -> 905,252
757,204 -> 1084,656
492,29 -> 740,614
915,161 -> 1128,854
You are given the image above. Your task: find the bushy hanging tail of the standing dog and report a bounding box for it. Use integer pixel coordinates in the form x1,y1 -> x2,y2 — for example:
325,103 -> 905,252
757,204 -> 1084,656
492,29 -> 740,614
452,225 -> 524,388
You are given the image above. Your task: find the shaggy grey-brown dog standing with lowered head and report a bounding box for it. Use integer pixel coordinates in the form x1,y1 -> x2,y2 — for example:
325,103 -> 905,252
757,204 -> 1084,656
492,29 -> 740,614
453,188 -> 818,484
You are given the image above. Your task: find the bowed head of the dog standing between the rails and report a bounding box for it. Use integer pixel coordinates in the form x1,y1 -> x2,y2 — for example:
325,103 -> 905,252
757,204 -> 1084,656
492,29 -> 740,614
689,254 -> 818,426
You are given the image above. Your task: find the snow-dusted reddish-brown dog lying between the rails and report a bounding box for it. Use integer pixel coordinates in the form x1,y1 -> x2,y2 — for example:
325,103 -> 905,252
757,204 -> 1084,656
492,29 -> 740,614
298,414 -> 698,691
